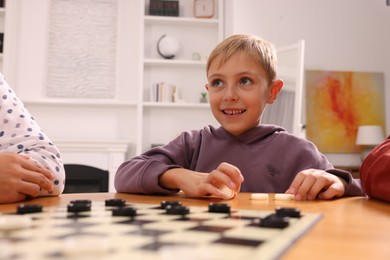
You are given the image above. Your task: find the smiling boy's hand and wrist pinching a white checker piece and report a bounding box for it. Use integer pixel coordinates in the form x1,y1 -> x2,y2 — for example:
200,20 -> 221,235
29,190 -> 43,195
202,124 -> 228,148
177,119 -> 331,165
160,163 -> 244,198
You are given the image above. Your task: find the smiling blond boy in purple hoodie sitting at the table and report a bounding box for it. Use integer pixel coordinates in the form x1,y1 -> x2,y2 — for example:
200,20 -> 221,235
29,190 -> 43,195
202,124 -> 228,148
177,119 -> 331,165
115,35 -> 363,200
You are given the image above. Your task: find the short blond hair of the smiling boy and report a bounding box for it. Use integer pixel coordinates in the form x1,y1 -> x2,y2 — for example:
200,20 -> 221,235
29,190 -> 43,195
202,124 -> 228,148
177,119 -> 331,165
206,34 -> 277,84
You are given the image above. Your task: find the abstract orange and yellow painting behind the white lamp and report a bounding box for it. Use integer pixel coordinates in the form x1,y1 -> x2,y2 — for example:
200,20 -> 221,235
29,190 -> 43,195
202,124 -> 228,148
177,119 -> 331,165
305,70 -> 385,153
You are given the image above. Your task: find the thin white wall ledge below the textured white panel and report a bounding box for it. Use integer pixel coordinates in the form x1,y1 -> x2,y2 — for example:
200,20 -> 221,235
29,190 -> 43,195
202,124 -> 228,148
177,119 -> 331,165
23,98 -> 137,107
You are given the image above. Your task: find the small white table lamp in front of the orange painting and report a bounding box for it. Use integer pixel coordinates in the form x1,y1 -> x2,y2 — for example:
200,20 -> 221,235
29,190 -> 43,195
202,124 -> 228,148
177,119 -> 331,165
356,125 -> 385,160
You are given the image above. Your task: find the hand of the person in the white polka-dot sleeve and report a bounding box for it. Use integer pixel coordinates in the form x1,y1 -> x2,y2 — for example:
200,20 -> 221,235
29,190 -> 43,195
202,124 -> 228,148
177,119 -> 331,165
0,153 -> 54,203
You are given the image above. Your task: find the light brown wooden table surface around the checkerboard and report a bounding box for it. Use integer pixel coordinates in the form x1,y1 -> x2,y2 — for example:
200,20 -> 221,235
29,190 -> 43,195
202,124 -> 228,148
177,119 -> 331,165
0,193 -> 390,260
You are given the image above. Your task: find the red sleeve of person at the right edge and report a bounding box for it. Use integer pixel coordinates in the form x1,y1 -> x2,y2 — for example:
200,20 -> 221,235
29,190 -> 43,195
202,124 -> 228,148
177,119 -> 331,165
359,135 -> 390,202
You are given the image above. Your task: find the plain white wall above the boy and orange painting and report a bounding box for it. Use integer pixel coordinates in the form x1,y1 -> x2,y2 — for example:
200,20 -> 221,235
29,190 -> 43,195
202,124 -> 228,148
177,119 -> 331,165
226,0 -> 390,134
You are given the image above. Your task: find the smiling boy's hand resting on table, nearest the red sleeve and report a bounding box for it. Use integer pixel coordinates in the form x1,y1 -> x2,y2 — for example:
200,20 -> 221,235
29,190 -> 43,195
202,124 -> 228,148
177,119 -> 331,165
286,169 -> 347,200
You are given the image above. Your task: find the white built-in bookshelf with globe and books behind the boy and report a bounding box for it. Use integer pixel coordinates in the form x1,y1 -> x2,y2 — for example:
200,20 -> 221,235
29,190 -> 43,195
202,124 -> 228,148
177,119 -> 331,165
137,0 -> 224,153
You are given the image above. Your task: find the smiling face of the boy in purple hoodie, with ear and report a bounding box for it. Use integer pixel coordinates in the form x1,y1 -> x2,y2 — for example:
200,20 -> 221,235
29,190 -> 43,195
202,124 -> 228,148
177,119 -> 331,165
206,53 -> 283,136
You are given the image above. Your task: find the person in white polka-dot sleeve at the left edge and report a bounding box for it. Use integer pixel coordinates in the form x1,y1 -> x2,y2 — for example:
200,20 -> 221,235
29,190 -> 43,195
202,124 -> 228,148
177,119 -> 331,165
0,74 -> 65,204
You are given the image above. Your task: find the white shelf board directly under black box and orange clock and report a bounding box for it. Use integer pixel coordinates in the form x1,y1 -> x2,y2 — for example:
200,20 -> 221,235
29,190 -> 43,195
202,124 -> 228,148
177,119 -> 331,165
145,15 -> 219,26
